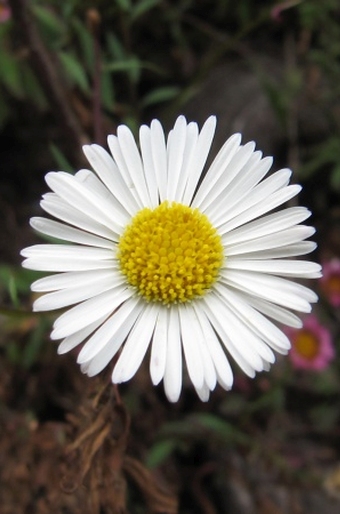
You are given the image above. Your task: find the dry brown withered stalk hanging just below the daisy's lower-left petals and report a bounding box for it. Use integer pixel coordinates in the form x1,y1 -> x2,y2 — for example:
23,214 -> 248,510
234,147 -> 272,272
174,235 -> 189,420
61,379 -> 178,514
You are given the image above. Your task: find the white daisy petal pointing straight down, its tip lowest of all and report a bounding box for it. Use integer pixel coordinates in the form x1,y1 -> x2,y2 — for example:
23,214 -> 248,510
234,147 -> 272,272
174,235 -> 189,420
164,305 -> 182,402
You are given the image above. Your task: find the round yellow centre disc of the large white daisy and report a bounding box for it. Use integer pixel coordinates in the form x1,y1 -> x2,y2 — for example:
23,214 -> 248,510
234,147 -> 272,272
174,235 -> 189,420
117,202 -> 223,304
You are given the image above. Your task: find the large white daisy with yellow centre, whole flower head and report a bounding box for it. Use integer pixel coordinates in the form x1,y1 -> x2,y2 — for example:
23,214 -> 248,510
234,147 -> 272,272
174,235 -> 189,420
22,116 -> 321,402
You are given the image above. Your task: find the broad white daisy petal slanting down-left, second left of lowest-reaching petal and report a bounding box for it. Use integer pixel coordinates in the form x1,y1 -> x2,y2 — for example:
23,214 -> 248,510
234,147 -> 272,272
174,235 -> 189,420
112,303 -> 158,384
